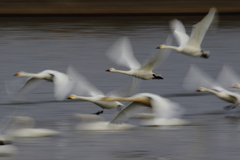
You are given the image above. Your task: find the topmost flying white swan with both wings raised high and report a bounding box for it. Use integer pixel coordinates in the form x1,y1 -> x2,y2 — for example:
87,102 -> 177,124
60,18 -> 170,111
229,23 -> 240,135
157,8 -> 217,58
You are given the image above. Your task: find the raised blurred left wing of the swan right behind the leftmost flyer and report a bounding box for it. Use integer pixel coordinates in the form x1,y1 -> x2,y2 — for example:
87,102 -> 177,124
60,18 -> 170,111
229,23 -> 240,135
67,66 -> 104,97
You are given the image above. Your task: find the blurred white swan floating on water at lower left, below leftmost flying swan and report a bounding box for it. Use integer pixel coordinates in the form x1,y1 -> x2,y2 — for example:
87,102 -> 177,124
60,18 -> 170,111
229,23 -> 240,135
7,116 -> 60,138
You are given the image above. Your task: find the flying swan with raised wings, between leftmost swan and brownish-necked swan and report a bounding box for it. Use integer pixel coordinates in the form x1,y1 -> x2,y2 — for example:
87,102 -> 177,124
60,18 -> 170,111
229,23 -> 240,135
68,67 -> 137,115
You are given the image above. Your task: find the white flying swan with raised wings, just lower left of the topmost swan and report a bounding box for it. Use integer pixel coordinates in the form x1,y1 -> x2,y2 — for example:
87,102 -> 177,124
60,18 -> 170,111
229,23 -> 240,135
106,37 -> 171,80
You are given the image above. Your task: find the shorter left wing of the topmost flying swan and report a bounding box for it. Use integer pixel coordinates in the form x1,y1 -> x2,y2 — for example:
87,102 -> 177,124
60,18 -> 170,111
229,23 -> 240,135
170,19 -> 189,47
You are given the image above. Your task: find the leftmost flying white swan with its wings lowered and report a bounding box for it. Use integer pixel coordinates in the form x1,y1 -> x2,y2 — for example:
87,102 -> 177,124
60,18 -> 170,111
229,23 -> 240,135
15,70 -> 73,100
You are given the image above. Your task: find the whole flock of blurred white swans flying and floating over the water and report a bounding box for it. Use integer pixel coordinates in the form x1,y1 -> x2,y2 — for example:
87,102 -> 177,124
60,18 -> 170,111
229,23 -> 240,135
0,8 -> 240,156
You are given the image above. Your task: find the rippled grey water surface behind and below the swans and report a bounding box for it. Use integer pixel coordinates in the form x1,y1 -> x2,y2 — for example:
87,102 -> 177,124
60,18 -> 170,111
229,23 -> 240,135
0,16 -> 240,160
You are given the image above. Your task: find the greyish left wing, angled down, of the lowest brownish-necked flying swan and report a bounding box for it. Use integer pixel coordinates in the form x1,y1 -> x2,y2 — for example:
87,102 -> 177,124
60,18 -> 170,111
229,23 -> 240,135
110,102 -> 146,124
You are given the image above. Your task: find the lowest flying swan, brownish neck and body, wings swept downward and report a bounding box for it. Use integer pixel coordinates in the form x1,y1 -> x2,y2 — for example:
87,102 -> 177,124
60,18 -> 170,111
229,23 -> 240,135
101,93 -> 183,125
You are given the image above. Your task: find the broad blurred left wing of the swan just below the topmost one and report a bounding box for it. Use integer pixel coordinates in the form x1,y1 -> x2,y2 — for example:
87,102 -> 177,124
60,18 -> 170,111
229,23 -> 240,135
106,37 -> 141,69
